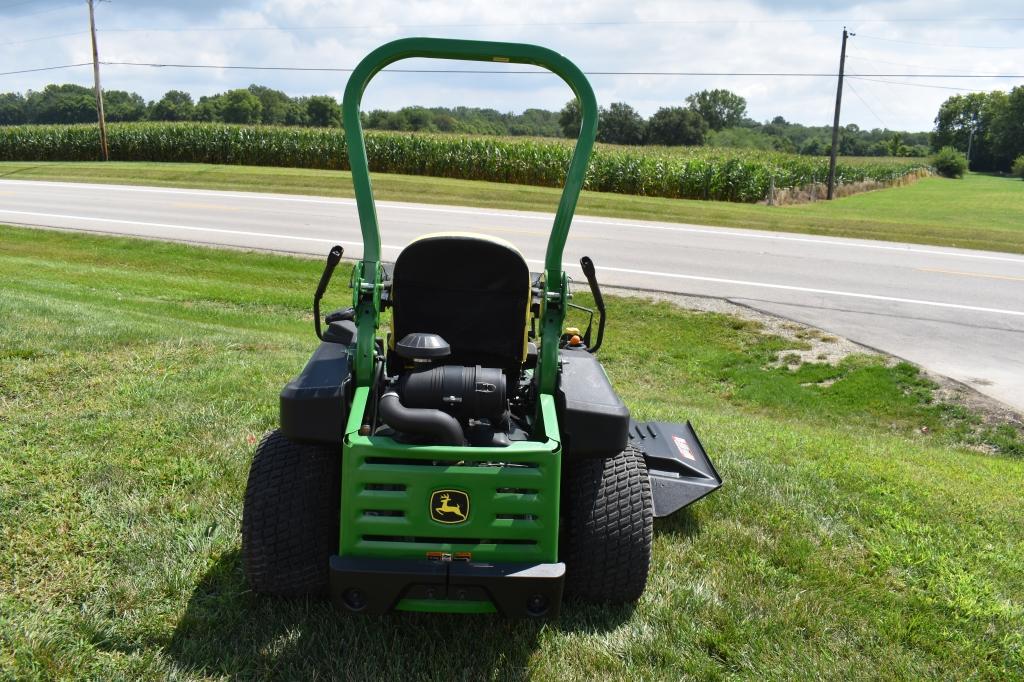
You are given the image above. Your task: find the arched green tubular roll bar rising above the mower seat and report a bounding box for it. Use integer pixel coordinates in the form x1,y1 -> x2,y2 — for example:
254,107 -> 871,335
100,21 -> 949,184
342,38 -> 597,394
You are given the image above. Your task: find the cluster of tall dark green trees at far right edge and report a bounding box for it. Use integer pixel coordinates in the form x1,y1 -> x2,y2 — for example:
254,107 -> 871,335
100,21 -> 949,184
932,86 -> 1024,173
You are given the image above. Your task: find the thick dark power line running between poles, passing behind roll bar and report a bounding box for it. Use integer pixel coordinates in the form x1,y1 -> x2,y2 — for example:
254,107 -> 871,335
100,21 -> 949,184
101,61 -> 1024,79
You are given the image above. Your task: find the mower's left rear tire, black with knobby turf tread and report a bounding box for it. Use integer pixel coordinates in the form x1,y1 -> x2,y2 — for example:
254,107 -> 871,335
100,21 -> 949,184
242,430 -> 341,598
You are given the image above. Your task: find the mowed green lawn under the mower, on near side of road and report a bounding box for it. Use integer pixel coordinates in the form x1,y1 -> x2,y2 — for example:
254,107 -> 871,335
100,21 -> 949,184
0,227 -> 1024,681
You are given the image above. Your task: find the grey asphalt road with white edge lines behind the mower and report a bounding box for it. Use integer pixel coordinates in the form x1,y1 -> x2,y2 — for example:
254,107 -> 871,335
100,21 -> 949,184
6,180 -> 1024,412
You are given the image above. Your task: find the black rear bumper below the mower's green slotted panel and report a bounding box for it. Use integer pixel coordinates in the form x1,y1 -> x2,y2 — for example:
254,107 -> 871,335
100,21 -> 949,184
331,555 -> 565,617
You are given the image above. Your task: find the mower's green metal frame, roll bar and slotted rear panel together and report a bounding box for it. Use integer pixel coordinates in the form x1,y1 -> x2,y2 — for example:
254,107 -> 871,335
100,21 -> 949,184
338,38 -> 597,612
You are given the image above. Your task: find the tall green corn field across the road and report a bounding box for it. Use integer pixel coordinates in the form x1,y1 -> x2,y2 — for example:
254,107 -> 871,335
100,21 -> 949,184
0,123 -> 927,202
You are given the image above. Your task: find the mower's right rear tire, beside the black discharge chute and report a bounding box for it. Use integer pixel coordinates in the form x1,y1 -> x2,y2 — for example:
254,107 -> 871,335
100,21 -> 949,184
562,445 -> 654,603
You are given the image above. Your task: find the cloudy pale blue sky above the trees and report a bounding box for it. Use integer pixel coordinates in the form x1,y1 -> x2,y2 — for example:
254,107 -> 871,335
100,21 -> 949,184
0,0 -> 1024,131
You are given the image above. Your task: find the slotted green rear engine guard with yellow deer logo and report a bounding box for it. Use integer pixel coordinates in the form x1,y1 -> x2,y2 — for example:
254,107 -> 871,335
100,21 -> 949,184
339,434 -> 561,562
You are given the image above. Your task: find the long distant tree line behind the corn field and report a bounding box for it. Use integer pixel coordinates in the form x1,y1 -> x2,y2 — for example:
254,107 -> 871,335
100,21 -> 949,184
0,84 -> 930,157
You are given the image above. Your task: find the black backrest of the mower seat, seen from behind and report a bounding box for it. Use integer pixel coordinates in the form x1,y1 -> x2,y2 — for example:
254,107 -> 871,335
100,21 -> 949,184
391,233 -> 530,372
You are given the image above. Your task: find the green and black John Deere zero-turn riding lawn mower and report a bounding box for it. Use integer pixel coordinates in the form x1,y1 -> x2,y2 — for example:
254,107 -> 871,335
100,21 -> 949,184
242,38 -> 721,616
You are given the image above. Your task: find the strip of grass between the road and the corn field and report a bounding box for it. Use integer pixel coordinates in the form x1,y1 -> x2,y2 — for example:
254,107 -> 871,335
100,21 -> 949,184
0,162 -> 1024,253
